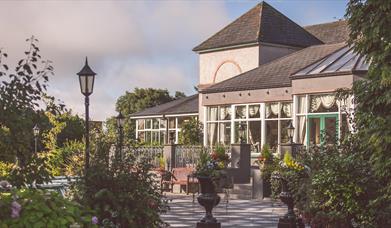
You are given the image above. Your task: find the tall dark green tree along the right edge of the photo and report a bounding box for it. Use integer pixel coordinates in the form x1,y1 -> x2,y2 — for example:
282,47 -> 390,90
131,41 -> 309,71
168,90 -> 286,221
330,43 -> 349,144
346,0 -> 391,227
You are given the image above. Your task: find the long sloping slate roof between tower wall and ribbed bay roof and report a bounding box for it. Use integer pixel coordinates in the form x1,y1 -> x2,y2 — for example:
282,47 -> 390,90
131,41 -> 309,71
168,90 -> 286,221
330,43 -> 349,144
200,43 -> 346,93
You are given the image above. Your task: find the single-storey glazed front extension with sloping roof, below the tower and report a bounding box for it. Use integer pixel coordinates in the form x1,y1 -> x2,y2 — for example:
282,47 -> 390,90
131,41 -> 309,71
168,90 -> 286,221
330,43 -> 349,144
201,43 -> 368,151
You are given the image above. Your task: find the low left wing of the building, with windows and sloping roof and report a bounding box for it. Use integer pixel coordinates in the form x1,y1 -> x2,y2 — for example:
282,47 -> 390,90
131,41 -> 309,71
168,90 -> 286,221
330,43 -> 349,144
130,94 -> 198,145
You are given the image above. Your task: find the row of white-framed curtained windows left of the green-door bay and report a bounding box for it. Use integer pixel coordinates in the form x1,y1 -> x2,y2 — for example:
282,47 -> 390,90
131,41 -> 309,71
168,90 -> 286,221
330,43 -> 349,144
206,102 -> 293,148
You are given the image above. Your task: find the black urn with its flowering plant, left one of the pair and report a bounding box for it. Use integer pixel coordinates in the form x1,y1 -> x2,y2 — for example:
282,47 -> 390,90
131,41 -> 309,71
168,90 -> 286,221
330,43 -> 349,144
195,151 -> 221,227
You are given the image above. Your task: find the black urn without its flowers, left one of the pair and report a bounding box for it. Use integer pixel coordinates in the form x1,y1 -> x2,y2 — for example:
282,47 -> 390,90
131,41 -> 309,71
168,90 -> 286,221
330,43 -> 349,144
197,176 -> 221,228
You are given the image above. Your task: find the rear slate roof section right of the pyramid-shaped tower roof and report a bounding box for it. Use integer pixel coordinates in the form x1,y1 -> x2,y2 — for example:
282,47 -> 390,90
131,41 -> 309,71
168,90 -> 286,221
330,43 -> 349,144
304,20 -> 349,44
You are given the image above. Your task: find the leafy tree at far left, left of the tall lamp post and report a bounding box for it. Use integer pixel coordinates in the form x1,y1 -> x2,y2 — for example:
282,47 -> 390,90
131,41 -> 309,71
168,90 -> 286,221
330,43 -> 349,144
0,36 -> 64,186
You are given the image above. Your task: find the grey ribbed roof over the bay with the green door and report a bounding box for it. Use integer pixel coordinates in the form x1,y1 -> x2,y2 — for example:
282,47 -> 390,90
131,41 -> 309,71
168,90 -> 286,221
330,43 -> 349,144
292,46 -> 369,78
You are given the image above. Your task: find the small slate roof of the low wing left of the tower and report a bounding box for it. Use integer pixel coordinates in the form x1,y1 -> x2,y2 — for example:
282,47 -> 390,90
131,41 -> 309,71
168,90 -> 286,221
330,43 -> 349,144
130,94 -> 198,117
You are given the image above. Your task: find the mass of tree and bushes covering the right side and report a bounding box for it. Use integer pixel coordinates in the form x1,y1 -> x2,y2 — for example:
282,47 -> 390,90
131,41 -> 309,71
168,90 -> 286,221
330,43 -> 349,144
268,0 -> 391,227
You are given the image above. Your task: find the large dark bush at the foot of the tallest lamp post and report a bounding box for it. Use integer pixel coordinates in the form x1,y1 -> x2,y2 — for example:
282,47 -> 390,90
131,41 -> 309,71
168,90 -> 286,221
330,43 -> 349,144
74,134 -> 167,228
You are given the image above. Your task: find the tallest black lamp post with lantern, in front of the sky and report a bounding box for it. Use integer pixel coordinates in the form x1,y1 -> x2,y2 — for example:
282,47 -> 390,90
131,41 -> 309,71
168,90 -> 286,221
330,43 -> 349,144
77,57 -> 96,171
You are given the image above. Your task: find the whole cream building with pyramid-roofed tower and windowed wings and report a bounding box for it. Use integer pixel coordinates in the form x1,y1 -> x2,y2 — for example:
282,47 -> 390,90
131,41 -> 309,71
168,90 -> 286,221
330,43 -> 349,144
132,2 -> 368,152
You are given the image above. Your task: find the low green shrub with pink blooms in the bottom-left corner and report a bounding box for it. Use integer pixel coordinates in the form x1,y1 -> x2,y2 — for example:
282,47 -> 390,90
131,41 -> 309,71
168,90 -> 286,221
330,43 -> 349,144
0,189 -> 96,227
